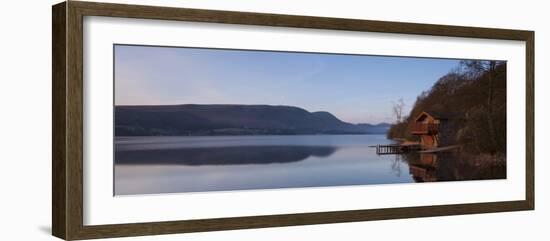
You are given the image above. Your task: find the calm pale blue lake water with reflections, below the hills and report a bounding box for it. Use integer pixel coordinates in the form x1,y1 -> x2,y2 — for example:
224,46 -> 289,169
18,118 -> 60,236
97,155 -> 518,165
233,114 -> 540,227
115,135 -> 506,195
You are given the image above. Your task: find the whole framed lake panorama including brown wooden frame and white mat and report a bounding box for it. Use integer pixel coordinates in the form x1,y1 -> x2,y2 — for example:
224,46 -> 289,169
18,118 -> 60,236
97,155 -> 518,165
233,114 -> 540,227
52,1 -> 534,240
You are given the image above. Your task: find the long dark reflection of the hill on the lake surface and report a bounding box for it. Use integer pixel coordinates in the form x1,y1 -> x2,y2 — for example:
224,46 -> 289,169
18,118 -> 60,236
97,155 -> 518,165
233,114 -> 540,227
115,146 -> 337,165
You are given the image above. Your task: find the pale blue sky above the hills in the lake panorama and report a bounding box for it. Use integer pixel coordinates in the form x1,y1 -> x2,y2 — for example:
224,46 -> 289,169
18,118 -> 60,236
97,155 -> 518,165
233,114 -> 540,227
115,45 -> 459,123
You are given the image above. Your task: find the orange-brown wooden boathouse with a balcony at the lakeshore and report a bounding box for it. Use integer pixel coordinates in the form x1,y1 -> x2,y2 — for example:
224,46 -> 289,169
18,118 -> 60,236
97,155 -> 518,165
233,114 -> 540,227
411,111 -> 449,149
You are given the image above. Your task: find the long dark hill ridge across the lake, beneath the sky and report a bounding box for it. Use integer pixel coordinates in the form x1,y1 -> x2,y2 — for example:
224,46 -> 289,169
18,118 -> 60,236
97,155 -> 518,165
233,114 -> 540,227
115,105 -> 392,136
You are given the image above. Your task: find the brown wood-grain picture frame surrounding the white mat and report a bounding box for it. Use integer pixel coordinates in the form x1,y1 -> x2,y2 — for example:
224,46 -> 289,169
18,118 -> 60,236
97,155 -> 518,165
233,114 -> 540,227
52,1 -> 535,240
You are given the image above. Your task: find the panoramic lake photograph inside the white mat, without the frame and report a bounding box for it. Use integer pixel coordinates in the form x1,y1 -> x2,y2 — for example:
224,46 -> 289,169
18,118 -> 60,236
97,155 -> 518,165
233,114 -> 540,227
114,44 -> 506,195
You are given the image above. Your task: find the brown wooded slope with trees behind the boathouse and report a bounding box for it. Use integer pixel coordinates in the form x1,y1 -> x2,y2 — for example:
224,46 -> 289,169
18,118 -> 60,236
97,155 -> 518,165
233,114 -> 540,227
387,60 -> 506,155
